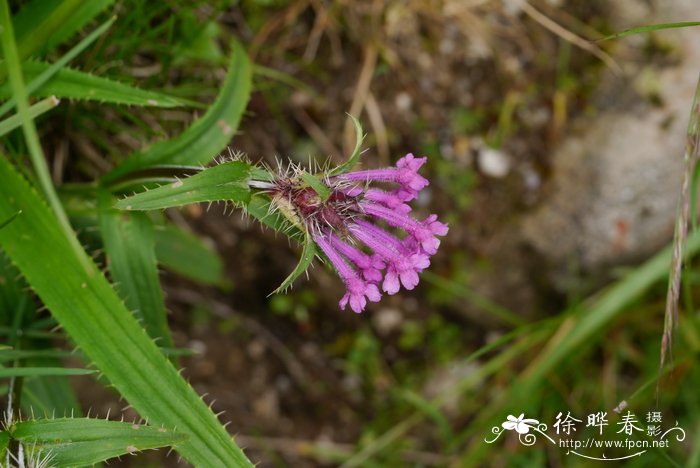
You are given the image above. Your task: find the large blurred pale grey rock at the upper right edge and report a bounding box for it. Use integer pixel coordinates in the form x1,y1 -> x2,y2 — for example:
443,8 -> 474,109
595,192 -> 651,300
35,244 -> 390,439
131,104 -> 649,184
522,0 -> 700,272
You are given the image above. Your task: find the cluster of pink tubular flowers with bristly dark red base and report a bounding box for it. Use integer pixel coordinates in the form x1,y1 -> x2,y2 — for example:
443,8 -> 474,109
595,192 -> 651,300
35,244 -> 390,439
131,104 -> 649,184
269,154 -> 449,313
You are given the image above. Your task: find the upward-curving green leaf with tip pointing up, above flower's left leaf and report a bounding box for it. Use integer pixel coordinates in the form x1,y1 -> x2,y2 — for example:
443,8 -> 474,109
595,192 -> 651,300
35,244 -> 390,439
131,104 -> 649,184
103,44 -> 251,184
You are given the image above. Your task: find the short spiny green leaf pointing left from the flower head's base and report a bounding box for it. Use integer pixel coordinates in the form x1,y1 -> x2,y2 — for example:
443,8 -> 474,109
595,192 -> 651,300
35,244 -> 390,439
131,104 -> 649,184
115,161 -> 250,210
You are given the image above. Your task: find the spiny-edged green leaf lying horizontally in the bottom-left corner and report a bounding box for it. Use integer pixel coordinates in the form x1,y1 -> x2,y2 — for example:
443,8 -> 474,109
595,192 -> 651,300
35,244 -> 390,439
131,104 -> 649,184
10,418 -> 187,467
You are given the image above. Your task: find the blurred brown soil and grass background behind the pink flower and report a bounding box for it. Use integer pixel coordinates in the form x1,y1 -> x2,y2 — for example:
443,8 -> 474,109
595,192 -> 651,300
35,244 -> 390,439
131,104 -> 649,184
4,0 -> 700,467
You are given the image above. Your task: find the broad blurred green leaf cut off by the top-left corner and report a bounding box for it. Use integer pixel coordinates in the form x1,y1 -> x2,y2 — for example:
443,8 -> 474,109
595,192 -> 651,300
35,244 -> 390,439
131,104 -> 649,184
12,0 -> 114,58
